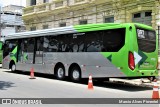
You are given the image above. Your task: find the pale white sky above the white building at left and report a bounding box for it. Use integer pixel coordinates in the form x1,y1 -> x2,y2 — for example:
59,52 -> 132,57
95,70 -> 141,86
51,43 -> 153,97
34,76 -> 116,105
0,0 -> 26,6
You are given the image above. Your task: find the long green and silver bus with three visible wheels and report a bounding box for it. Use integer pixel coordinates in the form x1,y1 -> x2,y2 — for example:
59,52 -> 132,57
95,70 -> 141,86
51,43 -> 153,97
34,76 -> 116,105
2,23 -> 158,81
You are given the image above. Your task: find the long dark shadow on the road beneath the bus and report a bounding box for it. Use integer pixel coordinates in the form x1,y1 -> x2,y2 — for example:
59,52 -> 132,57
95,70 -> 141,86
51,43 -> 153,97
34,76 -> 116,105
4,71 -> 153,92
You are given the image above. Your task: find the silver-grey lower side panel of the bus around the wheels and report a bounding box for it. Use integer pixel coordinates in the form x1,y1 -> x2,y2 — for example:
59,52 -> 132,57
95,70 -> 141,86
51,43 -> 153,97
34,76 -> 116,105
16,52 -> 126,78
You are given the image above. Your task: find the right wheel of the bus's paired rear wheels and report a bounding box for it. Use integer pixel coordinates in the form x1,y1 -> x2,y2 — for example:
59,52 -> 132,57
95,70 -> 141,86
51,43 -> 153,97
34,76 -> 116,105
70,67 -> 81,82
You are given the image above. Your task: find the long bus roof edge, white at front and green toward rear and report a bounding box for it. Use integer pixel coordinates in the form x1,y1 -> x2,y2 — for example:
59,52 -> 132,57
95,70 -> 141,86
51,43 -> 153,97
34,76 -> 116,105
5,23 -> 152,40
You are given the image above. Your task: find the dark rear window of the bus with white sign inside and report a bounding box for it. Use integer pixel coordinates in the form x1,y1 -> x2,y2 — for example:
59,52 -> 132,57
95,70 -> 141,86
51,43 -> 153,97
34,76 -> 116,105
137,28 -> 156,53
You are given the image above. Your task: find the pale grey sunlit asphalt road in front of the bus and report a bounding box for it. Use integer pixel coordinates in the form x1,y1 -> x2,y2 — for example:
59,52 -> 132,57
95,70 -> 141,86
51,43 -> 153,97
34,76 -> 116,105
0,69 -> 158,107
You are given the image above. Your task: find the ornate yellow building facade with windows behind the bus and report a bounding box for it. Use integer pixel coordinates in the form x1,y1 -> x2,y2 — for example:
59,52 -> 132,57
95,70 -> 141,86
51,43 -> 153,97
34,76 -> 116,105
23,0 -> 160,30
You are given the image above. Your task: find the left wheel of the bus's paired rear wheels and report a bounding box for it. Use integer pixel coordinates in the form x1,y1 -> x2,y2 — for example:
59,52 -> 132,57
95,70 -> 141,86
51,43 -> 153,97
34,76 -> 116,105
56,66 -> 65,80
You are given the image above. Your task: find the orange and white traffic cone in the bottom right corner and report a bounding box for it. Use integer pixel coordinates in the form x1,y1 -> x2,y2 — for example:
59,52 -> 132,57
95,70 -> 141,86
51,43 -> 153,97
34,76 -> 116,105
152,80 -> 159,99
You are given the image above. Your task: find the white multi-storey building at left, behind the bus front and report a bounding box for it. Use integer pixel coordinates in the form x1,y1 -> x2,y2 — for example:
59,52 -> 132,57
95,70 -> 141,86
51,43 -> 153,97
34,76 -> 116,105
0,5 -> 25,39
